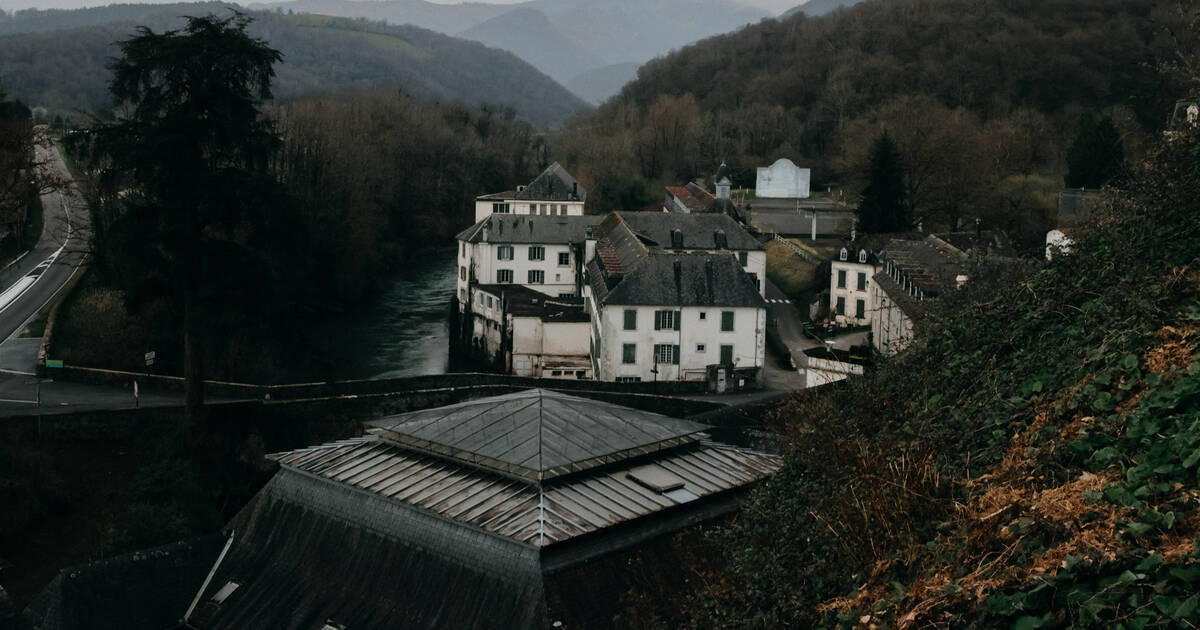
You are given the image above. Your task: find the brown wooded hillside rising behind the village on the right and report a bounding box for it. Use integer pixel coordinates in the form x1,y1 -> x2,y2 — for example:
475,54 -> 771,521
560,0 -> 1181,249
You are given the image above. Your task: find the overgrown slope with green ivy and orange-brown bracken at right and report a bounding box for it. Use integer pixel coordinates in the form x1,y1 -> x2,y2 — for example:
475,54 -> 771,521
672,127 -> 1200,628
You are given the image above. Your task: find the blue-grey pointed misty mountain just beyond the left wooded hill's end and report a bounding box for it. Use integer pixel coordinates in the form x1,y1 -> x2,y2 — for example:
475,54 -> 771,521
458,7 -> 605,84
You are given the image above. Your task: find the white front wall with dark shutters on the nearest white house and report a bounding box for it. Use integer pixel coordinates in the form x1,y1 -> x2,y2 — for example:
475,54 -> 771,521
587,301 -> 767,380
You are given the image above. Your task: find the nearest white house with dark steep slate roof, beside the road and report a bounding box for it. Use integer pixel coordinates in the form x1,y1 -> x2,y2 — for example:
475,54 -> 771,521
583,214 -> 767,382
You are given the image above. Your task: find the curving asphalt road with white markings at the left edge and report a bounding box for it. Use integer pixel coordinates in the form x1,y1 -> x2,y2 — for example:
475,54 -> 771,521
0,137 -> 90,340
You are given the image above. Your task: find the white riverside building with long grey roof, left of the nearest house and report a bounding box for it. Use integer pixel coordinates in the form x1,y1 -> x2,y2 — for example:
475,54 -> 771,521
456,215 -> 601,310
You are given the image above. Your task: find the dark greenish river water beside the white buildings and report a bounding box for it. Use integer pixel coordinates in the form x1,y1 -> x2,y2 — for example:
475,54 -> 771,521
319,248 -> 457,379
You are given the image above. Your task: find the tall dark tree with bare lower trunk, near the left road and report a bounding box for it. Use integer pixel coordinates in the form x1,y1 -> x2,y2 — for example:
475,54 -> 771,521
83,12 -> 282,425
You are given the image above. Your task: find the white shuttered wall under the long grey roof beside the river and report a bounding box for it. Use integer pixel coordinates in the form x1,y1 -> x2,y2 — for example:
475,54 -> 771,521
457,240 -> 578,302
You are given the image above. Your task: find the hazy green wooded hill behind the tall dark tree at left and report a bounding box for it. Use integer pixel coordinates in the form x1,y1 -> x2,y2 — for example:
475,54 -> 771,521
0,2 -> 587,127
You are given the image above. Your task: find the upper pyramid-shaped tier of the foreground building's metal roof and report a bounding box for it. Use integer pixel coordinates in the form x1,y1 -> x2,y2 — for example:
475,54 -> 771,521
368,389 -> 708,482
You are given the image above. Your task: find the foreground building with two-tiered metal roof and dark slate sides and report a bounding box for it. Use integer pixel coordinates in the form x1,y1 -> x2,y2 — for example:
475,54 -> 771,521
180,390 -> 781,630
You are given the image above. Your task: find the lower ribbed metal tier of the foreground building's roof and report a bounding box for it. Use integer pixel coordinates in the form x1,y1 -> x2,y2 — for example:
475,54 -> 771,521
272,434 -> 780,547
